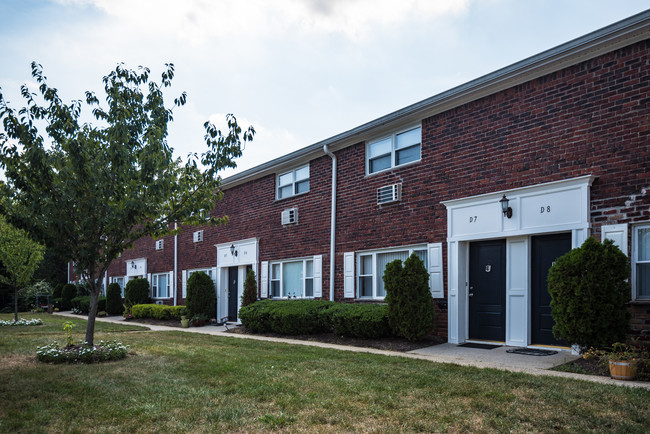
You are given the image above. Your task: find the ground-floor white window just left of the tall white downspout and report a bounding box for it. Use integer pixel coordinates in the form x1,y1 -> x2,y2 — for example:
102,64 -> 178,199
269,259 -> 314,298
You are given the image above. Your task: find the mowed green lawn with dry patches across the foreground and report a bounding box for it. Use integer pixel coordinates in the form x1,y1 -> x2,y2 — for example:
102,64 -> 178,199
0,314 -> 650,432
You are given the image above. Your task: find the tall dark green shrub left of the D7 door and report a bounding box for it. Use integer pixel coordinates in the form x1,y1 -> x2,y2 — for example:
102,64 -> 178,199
384,254 -> 435,341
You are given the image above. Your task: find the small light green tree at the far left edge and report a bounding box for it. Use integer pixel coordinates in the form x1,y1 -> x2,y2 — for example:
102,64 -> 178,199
0,216 -> 45,321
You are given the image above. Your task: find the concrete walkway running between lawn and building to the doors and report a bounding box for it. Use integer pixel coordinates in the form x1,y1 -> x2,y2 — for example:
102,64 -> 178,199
54,312 -> 650,390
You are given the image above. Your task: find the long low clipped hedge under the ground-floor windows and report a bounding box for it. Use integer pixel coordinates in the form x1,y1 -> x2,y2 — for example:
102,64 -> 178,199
239,300 -> 391,339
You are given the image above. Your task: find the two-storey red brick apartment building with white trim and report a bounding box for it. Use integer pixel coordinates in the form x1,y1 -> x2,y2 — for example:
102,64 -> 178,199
71,11 -> 650,346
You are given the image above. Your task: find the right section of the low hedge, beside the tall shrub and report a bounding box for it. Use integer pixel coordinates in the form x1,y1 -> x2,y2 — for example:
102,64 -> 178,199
328,304 -> 391,339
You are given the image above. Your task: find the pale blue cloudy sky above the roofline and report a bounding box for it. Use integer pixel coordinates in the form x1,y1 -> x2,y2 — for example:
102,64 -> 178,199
0,0 -> 648,177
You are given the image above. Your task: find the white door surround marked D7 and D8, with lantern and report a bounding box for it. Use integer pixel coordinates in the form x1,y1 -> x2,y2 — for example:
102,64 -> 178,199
443,175 -> 595,346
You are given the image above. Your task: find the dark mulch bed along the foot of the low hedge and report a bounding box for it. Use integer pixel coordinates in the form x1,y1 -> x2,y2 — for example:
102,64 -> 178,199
228,326 -> 446,352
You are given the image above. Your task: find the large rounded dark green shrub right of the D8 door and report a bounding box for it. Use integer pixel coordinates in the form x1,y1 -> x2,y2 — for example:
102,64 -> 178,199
548,237 -> 630,348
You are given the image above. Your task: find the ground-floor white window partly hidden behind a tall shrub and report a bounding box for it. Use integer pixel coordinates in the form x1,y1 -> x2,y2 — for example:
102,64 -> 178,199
357,246 -> 427,299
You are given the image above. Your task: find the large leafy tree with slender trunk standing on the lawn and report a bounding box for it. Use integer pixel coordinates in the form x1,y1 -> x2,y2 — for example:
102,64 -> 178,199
0,63 -> 255,344
